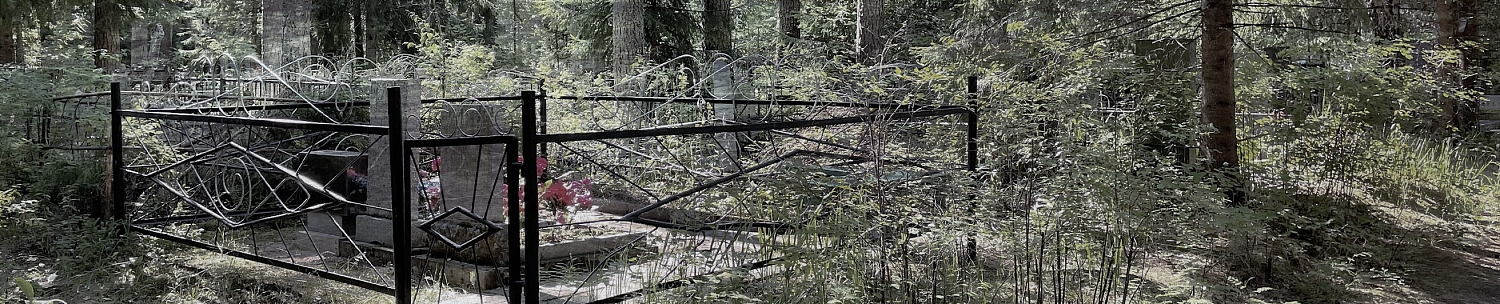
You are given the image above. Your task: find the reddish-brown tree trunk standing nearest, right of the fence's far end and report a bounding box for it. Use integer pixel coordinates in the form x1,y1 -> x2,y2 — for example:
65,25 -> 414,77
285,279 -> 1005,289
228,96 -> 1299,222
1202,0 -> 1244,204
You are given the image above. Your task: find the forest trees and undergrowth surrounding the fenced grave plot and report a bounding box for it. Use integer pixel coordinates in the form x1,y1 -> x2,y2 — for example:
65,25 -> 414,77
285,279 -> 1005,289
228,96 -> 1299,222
0,0 -> 1500,303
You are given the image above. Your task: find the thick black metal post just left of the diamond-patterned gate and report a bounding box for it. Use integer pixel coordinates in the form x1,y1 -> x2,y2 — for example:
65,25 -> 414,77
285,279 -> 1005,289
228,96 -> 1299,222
386,87 -> 411,304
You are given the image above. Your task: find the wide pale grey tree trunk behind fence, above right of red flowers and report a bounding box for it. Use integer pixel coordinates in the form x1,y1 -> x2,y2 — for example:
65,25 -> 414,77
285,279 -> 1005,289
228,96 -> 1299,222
611,0 -> 648,79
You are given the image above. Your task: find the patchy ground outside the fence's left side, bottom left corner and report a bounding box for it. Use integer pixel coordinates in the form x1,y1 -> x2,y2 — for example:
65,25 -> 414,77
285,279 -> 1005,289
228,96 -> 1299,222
0,190 -> 392,304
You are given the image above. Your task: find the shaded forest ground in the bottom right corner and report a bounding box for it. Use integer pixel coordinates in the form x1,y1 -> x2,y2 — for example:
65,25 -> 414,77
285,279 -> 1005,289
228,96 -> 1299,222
1211,184 -> 1500,304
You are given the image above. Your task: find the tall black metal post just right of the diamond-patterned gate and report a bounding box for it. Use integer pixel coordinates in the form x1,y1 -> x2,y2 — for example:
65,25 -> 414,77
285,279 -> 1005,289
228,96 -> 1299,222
521,91 -> 542,303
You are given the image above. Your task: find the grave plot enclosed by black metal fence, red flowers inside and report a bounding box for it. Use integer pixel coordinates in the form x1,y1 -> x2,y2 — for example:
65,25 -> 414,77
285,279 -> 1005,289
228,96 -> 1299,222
111,74 -> 977,303
